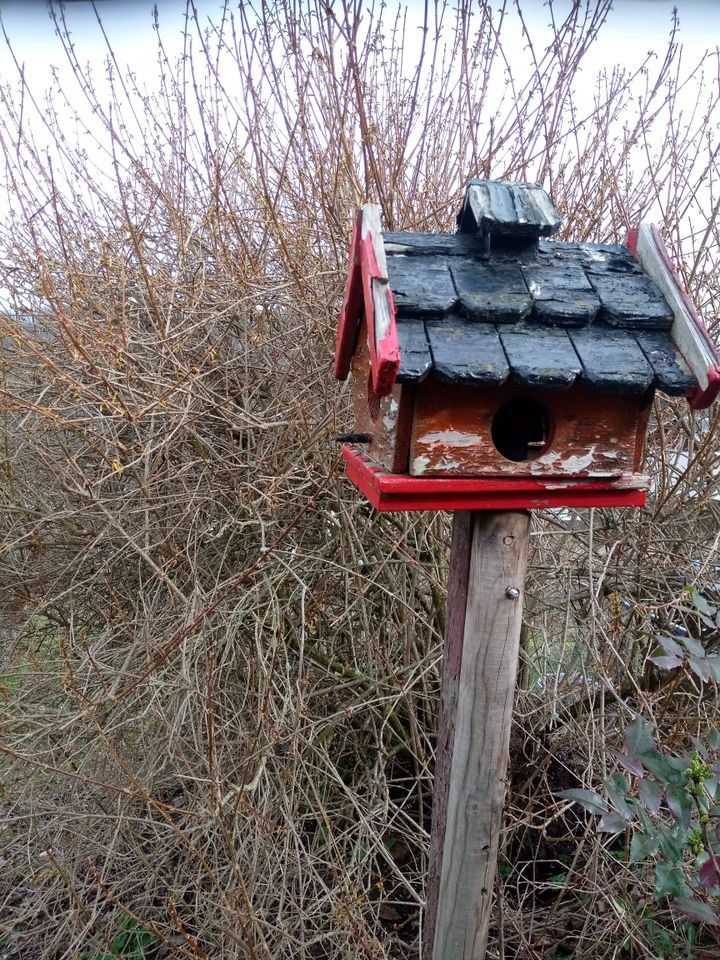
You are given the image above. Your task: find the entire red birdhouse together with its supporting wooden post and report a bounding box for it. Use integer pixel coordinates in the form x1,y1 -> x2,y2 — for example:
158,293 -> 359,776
335,180 -> 720,960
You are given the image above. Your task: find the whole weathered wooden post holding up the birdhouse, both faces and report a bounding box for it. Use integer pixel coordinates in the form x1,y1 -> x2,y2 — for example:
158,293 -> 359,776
423,510 -> 530,960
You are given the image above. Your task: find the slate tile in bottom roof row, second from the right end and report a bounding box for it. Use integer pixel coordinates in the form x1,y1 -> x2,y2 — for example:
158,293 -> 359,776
568,323 -> 655,393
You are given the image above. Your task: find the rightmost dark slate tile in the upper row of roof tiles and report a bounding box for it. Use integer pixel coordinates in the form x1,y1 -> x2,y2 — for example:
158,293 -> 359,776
588,272 -> 673,330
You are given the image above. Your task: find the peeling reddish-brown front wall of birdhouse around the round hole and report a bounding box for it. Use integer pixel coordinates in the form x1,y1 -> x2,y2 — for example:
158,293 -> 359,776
409,378 -> 649,479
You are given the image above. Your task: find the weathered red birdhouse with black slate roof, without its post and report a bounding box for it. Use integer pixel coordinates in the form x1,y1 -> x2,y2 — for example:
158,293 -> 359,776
335,180 -> 720,510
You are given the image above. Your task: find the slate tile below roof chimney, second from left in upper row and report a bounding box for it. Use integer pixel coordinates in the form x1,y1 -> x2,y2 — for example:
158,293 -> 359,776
450,259 -> 532,323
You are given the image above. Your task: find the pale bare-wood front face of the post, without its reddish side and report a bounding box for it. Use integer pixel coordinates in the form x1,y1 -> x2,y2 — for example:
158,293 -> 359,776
432,511 -> 530,960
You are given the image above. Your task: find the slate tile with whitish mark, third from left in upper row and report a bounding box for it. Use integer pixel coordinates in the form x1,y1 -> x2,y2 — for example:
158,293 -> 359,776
521,258 -> 600,327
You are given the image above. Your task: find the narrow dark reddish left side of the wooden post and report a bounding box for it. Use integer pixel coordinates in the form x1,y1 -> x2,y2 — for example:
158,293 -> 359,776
423,510 -> 473,960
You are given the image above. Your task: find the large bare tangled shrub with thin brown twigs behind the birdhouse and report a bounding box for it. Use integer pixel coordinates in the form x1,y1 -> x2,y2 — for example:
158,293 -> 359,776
0,0 -> 719,960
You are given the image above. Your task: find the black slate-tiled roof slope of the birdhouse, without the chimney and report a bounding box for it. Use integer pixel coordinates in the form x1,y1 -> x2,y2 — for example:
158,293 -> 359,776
384,231 -> 695,395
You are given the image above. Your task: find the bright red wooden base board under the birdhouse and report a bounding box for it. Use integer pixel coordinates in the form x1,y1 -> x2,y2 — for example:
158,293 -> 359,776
343,445 -> 649,513
